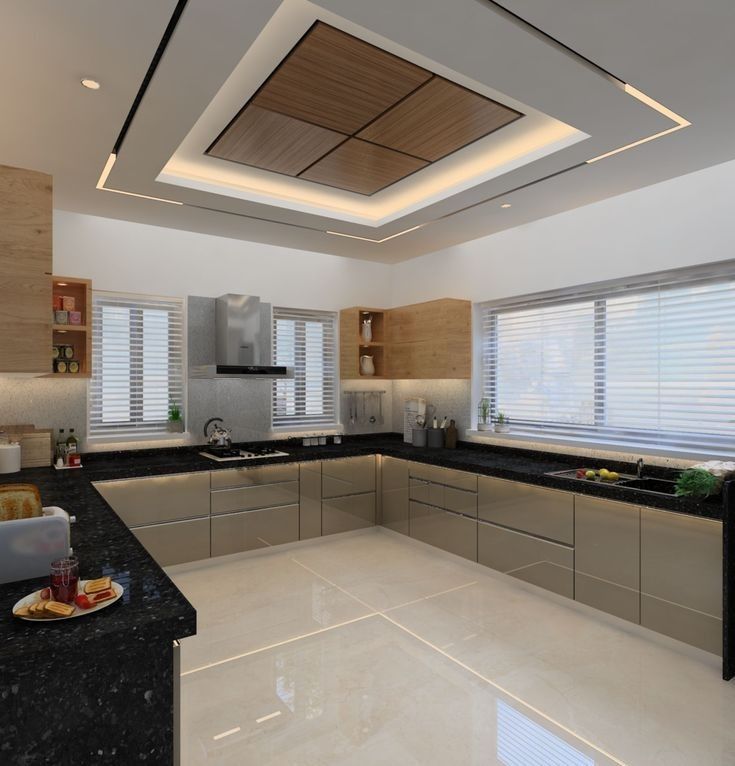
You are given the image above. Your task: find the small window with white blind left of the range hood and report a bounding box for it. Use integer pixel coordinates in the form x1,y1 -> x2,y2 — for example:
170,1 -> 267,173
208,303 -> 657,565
89,291 -> 184,438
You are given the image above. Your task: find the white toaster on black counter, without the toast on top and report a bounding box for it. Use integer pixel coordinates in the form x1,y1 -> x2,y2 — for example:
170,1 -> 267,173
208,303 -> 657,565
0,505 -> 76,583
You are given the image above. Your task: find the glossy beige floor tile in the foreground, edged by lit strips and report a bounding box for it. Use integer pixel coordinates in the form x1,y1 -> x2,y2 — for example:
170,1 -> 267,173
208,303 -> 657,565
182,616 -> 614,766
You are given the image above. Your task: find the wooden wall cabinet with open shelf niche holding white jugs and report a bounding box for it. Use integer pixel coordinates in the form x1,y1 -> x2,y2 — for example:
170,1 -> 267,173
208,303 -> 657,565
340,298 -> 472,380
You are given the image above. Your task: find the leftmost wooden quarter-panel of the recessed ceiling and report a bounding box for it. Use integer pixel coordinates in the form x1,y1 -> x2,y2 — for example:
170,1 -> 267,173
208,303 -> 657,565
208,104 -> 347,176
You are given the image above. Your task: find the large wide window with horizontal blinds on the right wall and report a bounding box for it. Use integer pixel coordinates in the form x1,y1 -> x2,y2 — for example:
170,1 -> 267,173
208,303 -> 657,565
480,262 -> 735,452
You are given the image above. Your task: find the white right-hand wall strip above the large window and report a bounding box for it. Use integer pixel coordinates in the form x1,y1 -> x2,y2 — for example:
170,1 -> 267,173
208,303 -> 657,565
391,161 -> 735,306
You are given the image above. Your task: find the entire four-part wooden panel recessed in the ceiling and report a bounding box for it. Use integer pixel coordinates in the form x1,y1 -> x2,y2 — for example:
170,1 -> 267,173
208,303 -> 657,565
207,21 -> 523,194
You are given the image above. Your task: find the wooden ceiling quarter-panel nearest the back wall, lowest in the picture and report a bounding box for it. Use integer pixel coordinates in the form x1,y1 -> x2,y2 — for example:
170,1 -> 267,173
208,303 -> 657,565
299,138 -> 429,194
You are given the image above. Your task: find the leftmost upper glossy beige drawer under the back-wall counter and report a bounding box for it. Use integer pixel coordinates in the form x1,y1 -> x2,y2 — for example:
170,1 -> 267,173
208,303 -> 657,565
94,471 -> 209,527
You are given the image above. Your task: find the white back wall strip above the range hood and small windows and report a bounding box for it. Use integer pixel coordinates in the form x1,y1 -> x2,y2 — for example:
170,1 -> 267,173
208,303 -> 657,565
54,210 -> 390,311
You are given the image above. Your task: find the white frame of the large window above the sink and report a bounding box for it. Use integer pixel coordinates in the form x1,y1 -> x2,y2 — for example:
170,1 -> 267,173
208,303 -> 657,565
472,260 -> 735,457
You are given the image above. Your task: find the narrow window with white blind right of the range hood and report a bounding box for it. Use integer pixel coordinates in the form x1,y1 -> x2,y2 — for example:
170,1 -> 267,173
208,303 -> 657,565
272,308 -> 337,430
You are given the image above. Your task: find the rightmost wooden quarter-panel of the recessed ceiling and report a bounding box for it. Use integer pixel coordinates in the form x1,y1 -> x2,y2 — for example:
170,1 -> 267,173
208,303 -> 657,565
357,77 -> 521,162
